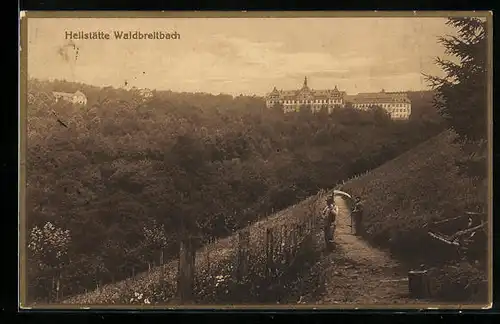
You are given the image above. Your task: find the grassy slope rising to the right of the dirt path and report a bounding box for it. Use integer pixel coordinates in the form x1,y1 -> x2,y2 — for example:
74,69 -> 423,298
342,131 -> 487,301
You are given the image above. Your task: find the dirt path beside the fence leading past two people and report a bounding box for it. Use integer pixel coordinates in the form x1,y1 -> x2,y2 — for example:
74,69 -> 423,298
310,197 -> 423,305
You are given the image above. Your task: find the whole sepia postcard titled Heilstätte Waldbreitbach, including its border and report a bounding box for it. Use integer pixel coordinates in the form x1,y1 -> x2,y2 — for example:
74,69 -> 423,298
19,11 -> 493,310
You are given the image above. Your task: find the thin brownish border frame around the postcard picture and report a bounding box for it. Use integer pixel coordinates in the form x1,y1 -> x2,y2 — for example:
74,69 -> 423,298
18,10 -> 493,311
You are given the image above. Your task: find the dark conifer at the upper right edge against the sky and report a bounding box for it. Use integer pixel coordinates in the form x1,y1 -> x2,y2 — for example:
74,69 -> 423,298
427,17 -> 493,179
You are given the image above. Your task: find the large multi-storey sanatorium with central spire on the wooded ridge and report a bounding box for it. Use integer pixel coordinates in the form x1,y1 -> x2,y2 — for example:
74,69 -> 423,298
266,77 -> 411,119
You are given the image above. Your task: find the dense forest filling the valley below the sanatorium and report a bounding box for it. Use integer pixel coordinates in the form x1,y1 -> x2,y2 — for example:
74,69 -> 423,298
26,80 -> 443,300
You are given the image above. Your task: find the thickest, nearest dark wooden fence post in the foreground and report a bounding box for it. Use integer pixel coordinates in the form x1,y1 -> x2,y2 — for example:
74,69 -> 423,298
177,238 -> 195,303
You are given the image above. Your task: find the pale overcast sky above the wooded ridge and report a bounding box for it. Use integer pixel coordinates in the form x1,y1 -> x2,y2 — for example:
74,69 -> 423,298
28,17 -> 453,95
